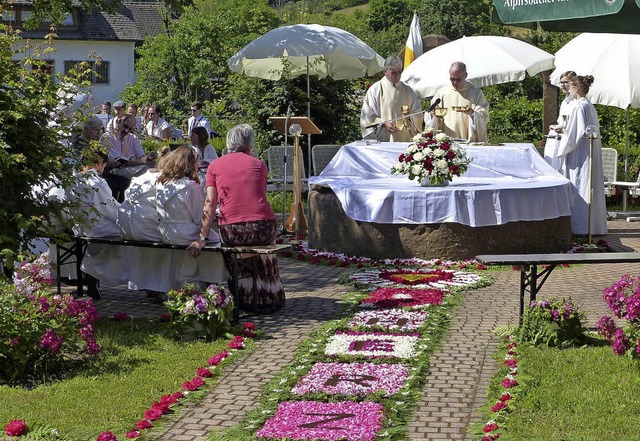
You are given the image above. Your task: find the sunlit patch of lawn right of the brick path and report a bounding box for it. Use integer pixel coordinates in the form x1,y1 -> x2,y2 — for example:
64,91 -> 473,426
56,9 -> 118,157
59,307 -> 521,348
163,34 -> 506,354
474,339 -> 640,441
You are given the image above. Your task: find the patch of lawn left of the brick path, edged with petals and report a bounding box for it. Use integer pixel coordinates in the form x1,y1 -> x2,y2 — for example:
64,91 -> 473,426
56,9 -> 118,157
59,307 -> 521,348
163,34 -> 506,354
0,318 -> 251,440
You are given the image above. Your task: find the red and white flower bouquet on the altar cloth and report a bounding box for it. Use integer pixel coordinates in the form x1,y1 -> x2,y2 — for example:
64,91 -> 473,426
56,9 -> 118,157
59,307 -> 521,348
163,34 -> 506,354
391,127 -> 471,185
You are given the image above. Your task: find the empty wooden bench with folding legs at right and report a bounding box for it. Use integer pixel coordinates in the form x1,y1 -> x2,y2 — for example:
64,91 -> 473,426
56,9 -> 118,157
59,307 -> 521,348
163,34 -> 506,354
476,252 -> 640,324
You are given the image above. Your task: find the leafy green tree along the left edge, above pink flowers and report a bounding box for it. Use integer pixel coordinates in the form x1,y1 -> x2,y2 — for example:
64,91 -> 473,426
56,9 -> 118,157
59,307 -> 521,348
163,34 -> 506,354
0,27 -> 92,262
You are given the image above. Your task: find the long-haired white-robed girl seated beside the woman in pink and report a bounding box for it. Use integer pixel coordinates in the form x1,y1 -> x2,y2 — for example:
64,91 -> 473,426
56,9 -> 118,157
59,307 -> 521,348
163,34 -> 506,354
156,146 -> 227,283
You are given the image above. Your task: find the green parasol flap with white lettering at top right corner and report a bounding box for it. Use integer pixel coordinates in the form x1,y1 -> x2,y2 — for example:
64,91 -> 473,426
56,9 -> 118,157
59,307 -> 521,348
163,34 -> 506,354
493,0 -> 624,24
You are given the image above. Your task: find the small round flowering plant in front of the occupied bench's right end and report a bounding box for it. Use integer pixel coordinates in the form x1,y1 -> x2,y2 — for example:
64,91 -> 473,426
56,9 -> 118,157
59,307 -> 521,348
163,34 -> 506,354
164,283 -> 233,341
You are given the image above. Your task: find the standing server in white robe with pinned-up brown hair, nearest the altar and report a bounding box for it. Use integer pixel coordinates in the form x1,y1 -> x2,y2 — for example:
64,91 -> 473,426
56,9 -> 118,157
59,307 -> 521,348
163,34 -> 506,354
558,75 -> 607,235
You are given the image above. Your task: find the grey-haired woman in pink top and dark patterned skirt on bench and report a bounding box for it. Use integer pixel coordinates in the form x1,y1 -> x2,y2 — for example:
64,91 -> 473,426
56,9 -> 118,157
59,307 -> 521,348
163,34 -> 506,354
189,124 -> 284,309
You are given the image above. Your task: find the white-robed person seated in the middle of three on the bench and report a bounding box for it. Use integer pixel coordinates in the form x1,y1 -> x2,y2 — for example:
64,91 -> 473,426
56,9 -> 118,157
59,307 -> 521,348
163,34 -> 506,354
116,146 -> 179,298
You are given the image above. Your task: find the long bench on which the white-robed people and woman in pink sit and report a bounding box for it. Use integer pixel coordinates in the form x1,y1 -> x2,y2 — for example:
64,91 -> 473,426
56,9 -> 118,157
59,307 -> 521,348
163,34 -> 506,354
56,236 -> 291,311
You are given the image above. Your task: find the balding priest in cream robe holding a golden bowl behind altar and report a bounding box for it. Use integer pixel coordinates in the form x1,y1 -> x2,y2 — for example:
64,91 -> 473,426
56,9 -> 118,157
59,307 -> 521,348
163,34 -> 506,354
425,61 -> 489,142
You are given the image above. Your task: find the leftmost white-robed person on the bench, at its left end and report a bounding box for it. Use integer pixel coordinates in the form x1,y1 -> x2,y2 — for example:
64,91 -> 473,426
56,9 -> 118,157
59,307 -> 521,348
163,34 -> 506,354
71,144 -> 131,300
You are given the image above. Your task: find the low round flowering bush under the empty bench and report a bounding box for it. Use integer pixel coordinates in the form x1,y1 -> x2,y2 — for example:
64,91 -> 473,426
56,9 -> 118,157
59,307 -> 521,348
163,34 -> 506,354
518,298 -> 585,347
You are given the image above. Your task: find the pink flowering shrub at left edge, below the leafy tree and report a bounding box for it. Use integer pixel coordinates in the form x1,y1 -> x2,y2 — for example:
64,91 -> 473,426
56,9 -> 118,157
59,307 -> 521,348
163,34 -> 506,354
0,256 -> 100,383
